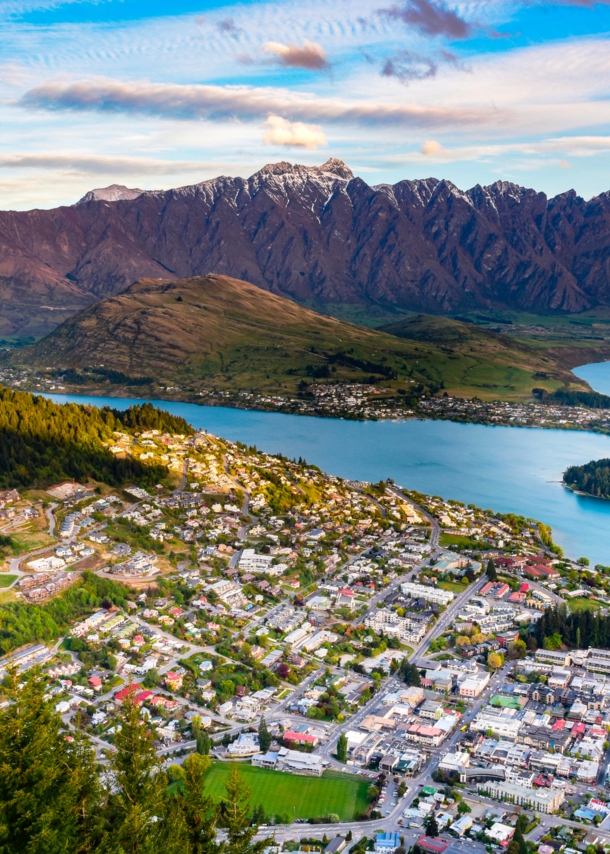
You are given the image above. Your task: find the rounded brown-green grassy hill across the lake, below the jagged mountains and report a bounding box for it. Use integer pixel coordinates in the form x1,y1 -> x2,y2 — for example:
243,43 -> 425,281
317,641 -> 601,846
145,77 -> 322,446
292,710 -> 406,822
12,275 -> 587,399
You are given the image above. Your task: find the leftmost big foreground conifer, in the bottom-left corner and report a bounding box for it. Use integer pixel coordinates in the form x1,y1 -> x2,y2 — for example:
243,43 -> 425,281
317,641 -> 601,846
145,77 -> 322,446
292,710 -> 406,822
0,671 -> 102,854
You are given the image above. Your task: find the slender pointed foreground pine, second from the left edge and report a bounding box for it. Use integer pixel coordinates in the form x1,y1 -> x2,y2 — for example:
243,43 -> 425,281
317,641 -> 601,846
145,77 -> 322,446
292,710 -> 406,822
102,695 -> 167,854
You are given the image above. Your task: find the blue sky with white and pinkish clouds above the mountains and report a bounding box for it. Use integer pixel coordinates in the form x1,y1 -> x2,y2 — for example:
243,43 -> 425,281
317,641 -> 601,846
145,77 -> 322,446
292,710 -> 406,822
0,0 -> 610,210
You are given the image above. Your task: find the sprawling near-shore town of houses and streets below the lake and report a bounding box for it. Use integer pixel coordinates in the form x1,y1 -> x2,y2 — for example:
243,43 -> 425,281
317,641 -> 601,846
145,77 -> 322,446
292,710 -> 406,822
0,422 -> 610,854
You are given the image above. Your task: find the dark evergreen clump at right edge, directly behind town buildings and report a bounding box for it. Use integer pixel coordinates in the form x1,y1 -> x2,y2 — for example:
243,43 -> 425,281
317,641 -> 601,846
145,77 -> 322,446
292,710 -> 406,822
534,604 -> 610,649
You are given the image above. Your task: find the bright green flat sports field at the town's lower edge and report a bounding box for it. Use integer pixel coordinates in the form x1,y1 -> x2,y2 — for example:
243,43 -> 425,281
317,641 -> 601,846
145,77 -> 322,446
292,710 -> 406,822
205,762 -> 370,821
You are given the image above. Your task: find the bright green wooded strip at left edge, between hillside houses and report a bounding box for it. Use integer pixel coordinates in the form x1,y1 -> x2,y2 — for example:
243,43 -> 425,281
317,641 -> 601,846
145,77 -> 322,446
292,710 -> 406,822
0,572 -> 129,655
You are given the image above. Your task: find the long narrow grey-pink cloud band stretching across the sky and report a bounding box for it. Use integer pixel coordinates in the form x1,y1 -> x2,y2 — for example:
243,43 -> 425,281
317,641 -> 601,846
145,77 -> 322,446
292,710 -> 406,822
17,79 -> 509,127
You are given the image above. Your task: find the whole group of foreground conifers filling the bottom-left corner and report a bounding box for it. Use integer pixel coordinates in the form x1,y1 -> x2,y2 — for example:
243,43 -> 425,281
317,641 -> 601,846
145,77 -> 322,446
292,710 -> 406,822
0,671 -> 268,854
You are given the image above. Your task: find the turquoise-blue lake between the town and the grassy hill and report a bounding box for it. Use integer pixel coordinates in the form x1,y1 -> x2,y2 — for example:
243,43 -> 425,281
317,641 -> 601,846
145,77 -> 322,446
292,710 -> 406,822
49,384 -> 610,565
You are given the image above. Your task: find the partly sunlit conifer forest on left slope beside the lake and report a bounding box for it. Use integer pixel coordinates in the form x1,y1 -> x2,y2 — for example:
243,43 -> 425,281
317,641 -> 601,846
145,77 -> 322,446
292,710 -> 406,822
0,387 -> 192,489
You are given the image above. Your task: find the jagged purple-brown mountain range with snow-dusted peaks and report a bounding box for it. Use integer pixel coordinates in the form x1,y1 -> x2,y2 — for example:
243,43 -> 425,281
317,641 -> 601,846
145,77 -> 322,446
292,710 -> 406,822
0,159 -> 610,333
